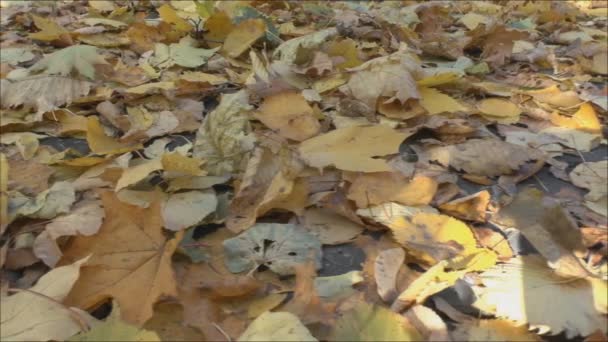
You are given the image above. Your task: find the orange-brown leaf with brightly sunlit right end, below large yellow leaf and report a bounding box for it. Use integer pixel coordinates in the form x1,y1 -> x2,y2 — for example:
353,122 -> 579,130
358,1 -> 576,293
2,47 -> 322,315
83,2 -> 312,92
346,172 -> 437,208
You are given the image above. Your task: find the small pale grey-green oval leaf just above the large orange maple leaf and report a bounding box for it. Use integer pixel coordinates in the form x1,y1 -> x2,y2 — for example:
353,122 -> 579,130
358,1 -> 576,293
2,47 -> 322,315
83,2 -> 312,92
162,190 -> 217,231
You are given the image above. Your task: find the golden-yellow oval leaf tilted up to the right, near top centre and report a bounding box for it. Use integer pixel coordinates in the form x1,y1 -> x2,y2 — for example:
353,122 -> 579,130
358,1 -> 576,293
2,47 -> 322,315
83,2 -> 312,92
222,19 -> 266,58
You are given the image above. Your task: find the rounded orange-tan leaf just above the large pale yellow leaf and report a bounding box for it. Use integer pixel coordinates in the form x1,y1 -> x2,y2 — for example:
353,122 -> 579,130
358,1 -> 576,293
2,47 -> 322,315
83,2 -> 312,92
254,92 -> 321,141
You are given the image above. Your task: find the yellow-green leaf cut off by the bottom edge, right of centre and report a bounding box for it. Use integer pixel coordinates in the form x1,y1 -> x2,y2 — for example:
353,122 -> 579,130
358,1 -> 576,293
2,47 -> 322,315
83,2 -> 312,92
329,302 -> 422,341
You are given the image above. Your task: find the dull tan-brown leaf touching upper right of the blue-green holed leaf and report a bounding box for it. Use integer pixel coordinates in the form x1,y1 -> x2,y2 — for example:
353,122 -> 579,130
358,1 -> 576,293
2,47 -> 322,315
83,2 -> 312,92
303,208 -> 365,245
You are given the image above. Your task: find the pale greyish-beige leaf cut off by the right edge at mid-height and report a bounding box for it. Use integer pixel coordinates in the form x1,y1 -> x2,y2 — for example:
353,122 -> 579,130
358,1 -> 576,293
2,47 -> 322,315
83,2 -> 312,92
570,160 -> 608,201
